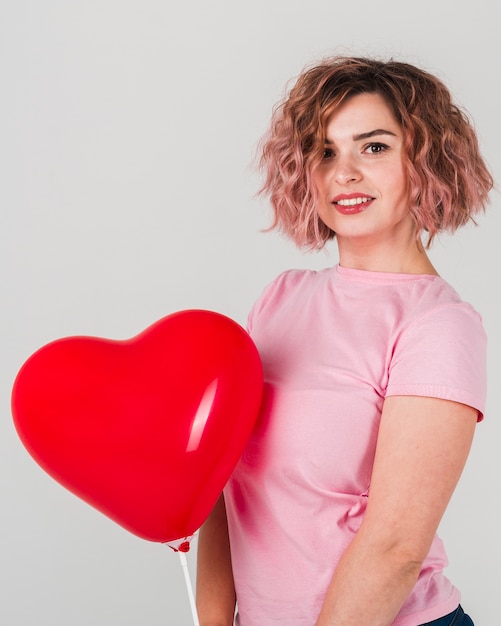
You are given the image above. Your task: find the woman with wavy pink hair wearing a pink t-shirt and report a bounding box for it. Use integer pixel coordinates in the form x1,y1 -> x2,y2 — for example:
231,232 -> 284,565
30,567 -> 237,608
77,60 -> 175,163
197,57 -> 492,626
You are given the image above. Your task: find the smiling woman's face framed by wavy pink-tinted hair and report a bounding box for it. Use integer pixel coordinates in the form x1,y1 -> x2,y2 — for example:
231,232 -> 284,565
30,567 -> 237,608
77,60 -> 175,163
314,93 -> 414,251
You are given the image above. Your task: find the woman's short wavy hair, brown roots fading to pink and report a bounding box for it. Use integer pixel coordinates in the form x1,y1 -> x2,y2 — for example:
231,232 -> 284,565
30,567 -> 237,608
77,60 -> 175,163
259,56 -> 493,249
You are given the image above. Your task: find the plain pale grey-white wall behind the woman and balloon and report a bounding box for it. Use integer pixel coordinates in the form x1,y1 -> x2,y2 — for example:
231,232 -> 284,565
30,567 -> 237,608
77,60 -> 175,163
0,0 -> 501,626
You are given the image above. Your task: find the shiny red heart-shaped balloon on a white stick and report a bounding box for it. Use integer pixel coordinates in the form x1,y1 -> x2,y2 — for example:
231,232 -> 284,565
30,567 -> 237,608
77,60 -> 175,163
12,310 -> 263,543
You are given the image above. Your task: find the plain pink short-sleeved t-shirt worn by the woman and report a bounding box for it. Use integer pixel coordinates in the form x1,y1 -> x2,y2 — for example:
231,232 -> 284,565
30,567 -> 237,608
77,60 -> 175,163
225,266 -> 486,626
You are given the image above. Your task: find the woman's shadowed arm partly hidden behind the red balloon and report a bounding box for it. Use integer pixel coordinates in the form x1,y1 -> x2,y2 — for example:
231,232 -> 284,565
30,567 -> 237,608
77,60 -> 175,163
197,496 -> 235,626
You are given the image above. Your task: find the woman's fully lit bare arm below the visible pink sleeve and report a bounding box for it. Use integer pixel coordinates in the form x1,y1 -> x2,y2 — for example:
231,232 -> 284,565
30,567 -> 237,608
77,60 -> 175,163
316,396 -> 478,626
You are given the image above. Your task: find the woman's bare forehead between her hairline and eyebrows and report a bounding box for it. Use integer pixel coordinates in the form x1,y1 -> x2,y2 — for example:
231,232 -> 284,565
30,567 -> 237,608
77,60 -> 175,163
326,93 -> 402,138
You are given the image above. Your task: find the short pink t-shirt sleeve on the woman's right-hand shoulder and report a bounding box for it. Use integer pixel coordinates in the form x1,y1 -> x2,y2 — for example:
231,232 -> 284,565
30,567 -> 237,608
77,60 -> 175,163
386,302 -> 487,421
